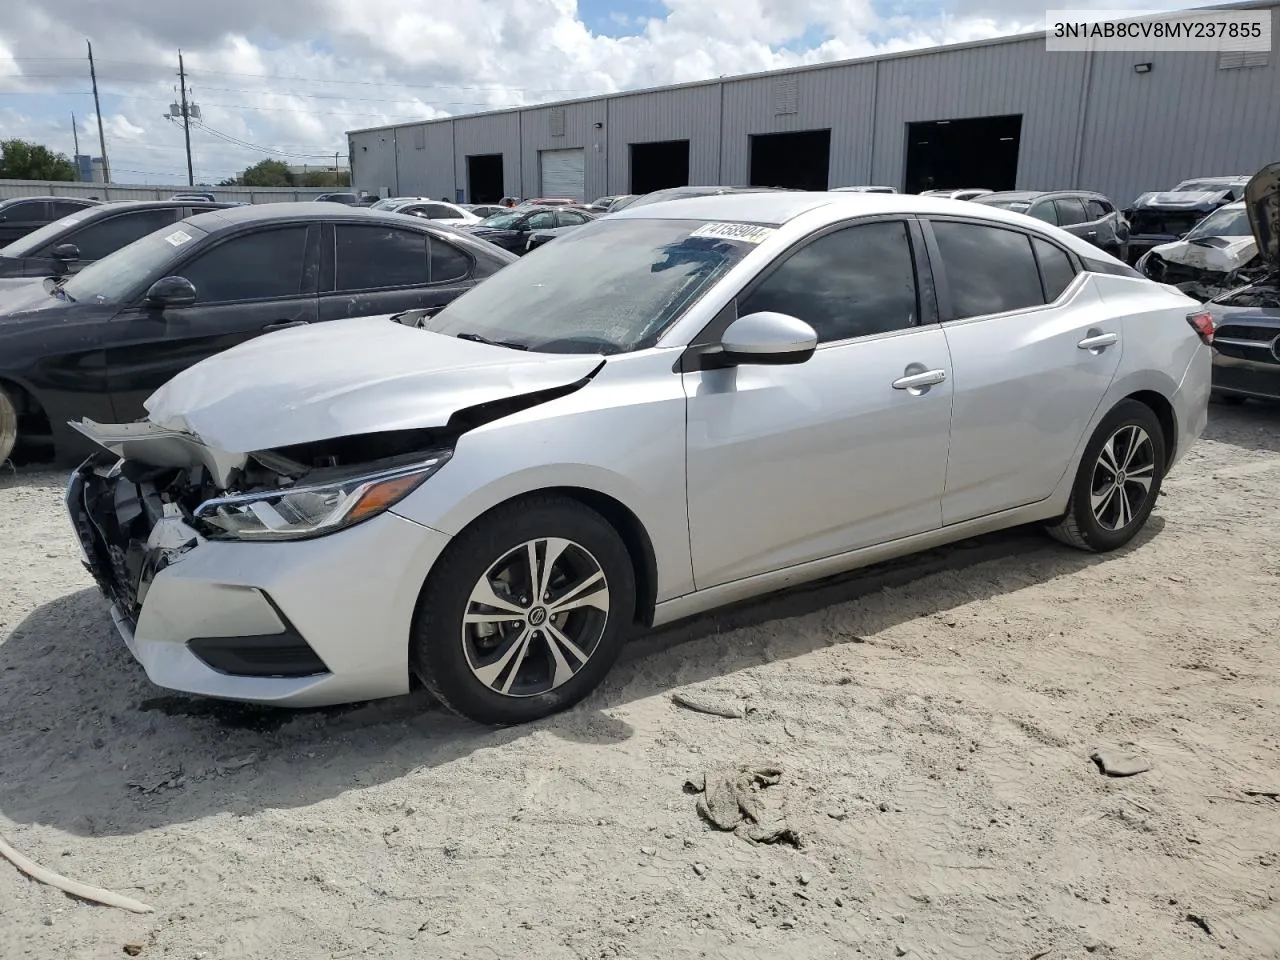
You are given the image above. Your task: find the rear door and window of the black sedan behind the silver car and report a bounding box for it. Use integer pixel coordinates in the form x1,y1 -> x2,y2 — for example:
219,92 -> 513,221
319,223 -> 474,320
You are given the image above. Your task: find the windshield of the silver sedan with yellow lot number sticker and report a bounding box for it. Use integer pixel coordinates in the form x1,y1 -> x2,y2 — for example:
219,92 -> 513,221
422,220 -> 753,353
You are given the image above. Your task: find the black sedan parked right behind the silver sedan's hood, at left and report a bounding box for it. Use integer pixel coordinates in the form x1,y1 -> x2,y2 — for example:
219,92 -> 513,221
0,202 -> 515,462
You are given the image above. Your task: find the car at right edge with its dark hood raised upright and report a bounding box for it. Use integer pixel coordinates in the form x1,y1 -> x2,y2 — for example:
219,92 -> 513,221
1204,163 -> 1280,403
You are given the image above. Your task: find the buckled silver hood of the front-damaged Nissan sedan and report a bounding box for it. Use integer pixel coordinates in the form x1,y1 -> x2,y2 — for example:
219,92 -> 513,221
146,316 -> 603,453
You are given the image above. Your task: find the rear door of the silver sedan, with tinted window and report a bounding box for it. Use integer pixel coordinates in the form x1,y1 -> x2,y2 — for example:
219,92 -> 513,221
932,221 -> 1124,524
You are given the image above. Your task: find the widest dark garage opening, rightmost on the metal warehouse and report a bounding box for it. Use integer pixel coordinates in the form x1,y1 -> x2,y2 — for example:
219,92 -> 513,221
906,114 -> 1023,193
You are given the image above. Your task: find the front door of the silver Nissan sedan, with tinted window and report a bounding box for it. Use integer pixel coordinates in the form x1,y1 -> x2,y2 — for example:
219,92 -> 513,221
684,219 -> 951,589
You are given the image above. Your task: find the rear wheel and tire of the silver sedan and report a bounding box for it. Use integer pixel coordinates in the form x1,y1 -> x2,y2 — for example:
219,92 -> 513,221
1048,399 -> 1167,553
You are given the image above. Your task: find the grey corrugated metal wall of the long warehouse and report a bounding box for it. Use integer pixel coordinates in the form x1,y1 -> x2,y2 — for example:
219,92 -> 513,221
351,6 -> 1280,205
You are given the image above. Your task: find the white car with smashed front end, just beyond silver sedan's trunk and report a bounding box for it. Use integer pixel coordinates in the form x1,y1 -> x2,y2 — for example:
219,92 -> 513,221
1134,202 -> 1268,301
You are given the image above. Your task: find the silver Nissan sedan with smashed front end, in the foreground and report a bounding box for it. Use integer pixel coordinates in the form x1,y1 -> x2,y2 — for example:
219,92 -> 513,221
67,191 -> 1212,723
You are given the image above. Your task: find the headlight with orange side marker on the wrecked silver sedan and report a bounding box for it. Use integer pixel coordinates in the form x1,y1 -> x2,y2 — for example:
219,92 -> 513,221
195,451 -> 449,540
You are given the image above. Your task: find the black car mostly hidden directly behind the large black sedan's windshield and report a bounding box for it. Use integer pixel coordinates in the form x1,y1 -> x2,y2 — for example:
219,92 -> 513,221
0,200 -> 232,276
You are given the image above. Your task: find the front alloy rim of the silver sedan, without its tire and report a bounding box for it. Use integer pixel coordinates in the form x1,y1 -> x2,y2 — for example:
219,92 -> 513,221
462,538 -> 609,696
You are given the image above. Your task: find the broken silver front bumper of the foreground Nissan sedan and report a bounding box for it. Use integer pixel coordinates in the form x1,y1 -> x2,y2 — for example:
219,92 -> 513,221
67,461 -> 448,707
